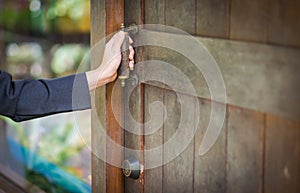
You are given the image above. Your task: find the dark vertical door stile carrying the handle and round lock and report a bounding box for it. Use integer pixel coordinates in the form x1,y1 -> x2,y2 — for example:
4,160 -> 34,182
124,0 -> 144,193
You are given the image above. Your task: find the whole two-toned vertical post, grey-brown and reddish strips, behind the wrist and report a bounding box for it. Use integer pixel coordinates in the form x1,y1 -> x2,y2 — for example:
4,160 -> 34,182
91,0 -> 124,193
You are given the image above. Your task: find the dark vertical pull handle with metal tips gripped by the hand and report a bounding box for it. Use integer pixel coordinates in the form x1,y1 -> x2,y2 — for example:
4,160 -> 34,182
118,24 -> 129,87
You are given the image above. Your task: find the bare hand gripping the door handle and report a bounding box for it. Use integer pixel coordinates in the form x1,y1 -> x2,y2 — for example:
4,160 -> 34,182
86,31 -> 134,91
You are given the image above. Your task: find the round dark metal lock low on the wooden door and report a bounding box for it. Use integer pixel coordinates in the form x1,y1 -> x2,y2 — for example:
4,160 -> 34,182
122,156 -> 140,179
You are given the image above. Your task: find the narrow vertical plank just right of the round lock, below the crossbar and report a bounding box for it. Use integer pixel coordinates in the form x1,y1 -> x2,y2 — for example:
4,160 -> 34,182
144,85 -> 163,193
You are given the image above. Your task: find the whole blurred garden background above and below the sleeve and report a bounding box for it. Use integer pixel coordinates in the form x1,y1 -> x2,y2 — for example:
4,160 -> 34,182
0,0 -> 91,192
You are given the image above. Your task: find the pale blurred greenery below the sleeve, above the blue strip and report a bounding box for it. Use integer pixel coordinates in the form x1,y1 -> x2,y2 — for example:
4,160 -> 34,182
0,117 -> 84,178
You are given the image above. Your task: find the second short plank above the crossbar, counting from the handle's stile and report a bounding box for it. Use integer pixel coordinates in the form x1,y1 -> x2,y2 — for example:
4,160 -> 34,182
165,0 -> 196,34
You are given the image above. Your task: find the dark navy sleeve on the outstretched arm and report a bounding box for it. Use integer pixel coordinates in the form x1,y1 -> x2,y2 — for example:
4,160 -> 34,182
0,71 -> 91,121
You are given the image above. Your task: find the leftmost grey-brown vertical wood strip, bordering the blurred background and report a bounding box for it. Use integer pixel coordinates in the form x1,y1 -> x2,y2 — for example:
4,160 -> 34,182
90,0 -> 106,193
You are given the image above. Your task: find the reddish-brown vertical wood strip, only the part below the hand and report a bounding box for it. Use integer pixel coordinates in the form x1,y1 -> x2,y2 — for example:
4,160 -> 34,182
106,81 -> 124,193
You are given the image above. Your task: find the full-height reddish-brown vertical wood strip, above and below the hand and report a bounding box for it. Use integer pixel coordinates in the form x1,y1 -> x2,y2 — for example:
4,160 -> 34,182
105,0 -> 124,193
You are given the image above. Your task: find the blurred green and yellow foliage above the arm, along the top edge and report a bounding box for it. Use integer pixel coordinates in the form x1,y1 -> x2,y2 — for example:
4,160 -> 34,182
0,0 -> 90,34
